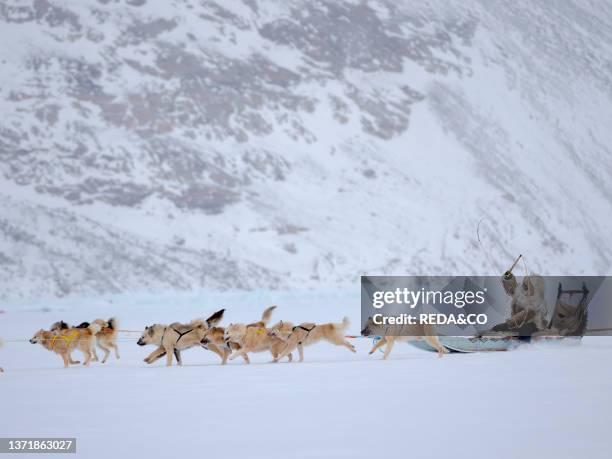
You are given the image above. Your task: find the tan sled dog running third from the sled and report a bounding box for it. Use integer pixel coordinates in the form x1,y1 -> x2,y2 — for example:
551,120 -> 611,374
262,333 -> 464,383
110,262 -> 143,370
225,321 -> 293,363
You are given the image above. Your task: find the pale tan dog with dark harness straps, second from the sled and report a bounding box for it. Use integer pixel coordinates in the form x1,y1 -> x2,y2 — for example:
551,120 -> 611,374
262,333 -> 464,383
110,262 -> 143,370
272,317 -> 357,362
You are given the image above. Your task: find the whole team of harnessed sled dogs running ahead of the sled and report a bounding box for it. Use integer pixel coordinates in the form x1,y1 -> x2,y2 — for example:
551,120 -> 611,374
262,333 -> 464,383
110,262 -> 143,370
7,306 -> 447,371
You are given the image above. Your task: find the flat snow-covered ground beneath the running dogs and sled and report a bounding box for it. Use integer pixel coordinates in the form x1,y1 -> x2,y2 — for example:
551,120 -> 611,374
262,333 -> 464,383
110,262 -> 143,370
0,292 -> 612,459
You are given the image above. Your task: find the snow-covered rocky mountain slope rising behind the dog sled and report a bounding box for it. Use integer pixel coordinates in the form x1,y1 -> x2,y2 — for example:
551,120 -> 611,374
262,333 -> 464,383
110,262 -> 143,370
0,0 -> 612,297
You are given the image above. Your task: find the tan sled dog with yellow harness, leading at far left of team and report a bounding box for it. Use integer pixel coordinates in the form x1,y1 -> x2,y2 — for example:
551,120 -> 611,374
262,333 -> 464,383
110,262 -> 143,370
30,324 -> 100,368
